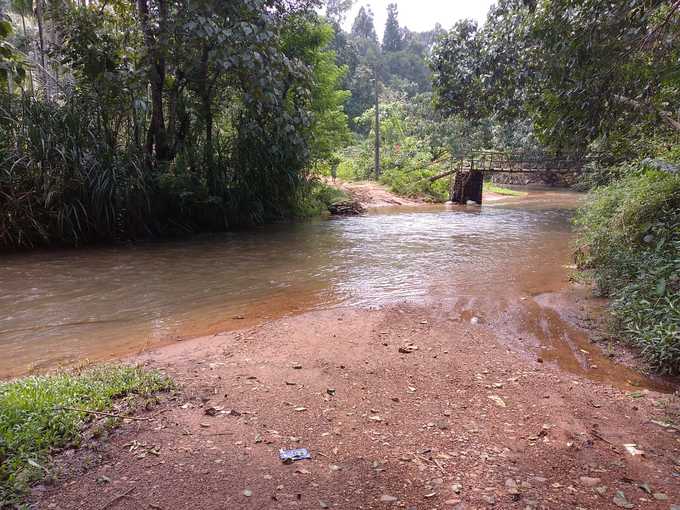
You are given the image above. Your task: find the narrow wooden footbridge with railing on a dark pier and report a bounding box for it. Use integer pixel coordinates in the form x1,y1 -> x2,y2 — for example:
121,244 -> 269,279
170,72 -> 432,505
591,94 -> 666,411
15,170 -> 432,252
429,151 -> 589,204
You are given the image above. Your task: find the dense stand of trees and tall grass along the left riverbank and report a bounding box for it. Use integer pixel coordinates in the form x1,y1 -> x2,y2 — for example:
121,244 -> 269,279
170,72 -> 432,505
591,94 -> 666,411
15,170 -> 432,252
0,0 -> 356,248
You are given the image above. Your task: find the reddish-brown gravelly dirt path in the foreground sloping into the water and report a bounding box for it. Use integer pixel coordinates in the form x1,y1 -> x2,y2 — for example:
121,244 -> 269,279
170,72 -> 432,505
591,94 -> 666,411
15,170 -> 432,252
35,290 -> 680,510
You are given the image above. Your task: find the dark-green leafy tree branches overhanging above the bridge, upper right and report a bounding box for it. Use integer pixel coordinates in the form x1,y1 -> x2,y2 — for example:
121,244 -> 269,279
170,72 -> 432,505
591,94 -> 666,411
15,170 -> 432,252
433,0 -> 680,157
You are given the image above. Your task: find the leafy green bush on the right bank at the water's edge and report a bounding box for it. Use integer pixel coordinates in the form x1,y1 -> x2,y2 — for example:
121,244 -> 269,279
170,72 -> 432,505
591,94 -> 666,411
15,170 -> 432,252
576,164 -> 680,373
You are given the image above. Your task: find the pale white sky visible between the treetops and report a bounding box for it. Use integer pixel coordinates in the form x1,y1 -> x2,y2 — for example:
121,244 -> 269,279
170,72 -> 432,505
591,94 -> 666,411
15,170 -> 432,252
338,0 -> 495,39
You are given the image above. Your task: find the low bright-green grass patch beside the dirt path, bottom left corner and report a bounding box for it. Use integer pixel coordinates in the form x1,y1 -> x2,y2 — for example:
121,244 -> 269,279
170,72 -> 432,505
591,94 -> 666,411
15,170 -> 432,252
0,365 -> 173,508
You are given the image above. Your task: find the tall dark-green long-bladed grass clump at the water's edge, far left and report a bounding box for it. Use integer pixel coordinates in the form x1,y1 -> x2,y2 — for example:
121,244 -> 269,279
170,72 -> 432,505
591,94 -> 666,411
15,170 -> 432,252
0,95 -> 149,249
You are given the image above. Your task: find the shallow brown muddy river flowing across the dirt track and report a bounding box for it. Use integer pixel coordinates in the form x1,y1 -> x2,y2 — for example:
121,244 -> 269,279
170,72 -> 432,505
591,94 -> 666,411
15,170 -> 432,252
0,192 -> 656,386
